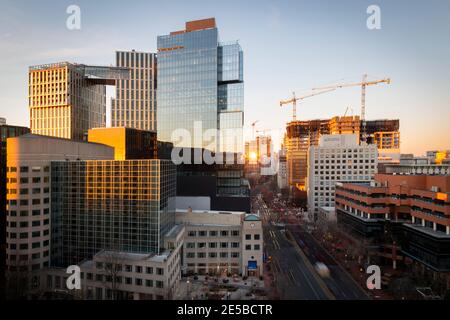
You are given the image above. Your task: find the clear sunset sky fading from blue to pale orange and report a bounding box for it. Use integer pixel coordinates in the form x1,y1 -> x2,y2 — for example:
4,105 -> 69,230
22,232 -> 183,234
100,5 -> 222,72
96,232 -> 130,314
0,0 -> 450,155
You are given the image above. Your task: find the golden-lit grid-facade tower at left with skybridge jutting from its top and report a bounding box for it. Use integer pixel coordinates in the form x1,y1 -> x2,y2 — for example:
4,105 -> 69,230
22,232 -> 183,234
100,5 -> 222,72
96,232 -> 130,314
28,62 -> 129,141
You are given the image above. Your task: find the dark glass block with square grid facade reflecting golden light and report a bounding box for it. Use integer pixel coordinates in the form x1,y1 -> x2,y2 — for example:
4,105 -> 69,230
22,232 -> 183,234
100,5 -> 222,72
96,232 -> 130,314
51,159 -> 176,267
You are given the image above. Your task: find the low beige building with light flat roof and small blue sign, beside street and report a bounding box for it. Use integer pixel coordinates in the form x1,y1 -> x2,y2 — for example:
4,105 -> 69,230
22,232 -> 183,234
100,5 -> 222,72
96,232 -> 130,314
176,209 -> 263,276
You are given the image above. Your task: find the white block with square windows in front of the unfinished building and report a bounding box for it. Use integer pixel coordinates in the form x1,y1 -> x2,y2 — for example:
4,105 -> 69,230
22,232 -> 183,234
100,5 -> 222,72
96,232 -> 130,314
307,134 -> 378,219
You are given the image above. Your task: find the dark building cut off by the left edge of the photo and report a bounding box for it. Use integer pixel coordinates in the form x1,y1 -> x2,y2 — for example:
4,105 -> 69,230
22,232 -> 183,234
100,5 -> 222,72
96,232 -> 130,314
0,118 -> 30,292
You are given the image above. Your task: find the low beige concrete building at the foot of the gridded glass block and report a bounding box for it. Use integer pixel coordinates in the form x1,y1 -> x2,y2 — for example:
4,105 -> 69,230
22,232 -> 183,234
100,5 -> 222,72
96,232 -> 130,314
39,226 -> 184,300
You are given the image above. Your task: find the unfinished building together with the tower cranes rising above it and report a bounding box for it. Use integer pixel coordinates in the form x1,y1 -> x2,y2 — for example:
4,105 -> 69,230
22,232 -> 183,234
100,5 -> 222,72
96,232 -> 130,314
280,75 -> 400,207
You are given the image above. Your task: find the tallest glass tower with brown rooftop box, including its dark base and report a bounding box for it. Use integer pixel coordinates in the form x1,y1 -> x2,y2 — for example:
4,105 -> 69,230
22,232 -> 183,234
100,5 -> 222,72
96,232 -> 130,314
157,18 -> 250,210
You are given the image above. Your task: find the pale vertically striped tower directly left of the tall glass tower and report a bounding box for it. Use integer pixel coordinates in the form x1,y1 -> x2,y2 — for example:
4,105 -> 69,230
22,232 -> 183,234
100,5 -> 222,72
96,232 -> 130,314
111,50 -> 156,131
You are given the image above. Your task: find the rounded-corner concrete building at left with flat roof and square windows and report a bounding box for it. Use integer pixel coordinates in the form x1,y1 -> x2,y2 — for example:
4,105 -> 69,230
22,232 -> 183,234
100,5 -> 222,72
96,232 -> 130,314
6,134 -> 114,272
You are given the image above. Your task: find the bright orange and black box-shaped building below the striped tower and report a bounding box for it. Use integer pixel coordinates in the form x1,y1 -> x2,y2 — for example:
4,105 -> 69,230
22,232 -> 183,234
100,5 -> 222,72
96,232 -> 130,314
88,127 -> 158,160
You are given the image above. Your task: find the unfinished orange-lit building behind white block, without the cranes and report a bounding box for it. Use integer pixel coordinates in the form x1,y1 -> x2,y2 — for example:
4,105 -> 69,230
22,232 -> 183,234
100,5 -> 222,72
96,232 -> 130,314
284,116 -> 400,204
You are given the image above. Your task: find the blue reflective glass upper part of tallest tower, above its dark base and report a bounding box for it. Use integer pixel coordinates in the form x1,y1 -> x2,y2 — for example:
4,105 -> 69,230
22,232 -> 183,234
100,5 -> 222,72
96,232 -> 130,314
157,18 -> 244,153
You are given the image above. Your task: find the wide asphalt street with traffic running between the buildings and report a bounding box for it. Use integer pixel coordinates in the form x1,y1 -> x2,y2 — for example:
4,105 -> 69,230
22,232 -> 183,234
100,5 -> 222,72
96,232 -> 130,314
254,197 -> 369,300
